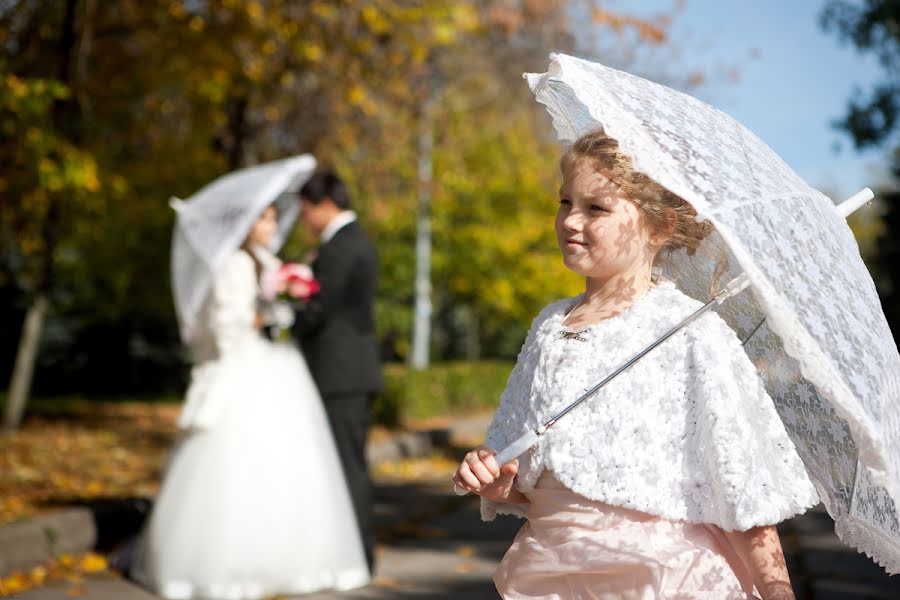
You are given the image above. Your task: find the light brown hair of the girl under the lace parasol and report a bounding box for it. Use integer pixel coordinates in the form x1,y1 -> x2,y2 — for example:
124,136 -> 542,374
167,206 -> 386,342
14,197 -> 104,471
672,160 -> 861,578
559,129 -> 728,288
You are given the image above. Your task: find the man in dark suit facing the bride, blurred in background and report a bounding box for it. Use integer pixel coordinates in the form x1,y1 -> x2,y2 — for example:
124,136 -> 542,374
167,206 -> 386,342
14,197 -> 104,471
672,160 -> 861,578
294,172 -> 382,571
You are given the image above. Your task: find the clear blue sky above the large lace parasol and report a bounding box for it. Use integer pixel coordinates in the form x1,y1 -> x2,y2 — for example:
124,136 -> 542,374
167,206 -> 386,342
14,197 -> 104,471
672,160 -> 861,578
608,0 -> 886,196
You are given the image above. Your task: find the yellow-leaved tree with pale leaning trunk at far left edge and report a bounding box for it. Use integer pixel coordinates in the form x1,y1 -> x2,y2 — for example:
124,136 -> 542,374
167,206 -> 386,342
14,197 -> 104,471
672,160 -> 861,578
0,0 -> 125,430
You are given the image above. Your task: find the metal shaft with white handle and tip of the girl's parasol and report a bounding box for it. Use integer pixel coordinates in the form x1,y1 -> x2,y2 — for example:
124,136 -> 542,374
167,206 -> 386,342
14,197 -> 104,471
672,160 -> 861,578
453,188 -> 875,496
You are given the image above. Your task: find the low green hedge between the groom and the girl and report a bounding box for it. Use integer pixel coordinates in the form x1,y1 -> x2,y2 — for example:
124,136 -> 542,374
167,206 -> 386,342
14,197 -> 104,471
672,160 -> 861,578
373,360 -> 513,427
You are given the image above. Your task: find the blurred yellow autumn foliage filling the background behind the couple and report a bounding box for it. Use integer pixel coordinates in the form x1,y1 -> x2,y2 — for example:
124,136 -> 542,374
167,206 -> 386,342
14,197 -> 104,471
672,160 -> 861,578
0,0 -> 688,426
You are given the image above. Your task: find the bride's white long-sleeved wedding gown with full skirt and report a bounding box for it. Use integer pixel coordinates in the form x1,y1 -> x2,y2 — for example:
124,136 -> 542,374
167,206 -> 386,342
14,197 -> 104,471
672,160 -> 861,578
132,250 -> 369,600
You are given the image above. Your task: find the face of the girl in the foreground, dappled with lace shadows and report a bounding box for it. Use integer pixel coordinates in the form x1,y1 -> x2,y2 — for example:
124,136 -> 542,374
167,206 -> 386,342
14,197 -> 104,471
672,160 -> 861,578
556,159 -> 658,280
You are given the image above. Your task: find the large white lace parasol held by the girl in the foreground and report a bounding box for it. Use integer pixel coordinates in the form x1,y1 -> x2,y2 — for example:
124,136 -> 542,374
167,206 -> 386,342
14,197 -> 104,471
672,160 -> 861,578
525,54 -> 900,573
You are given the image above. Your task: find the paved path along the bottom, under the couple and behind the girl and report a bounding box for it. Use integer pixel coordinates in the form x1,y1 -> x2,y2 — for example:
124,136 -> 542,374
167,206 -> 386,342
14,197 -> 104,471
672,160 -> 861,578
10,414 -> 900,600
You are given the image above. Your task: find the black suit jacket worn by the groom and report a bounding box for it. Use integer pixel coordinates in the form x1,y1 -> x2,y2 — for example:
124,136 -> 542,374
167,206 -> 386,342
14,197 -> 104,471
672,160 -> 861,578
293,221 -> 382,396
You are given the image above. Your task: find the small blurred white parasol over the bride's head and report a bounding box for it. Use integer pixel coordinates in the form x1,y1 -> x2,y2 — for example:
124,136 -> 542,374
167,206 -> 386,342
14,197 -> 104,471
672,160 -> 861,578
171,154 -> 316,343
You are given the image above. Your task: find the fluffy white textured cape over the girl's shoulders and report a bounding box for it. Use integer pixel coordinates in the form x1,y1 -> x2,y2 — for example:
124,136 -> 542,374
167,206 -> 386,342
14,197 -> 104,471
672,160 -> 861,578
482,282 -> 818,531
